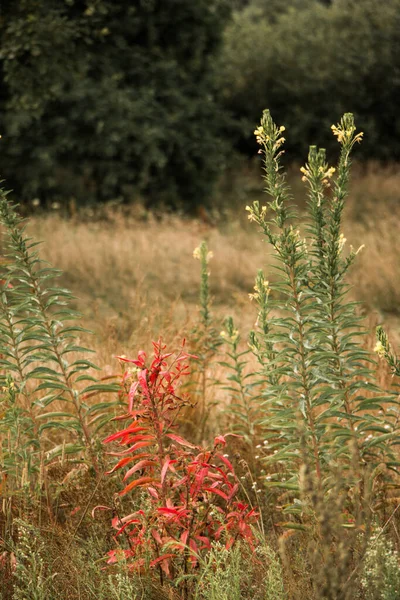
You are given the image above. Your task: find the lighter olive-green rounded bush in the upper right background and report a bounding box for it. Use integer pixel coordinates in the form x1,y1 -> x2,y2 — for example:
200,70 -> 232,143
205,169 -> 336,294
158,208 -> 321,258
221,0 -> 400,159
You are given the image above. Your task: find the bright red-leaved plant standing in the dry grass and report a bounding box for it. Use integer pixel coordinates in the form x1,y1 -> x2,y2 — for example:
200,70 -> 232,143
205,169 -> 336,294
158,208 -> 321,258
98,342 -> 258,578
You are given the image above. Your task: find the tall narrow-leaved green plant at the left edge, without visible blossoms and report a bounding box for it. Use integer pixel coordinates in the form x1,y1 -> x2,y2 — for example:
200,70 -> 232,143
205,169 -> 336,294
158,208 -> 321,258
0,184 -> 116,478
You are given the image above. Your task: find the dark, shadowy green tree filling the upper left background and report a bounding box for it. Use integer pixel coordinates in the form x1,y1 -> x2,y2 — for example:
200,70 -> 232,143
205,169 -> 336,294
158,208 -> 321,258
0,0 -> 229,207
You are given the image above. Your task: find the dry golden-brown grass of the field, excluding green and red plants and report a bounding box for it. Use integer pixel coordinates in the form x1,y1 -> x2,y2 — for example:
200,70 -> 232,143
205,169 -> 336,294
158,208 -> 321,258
0,159 -> 400,600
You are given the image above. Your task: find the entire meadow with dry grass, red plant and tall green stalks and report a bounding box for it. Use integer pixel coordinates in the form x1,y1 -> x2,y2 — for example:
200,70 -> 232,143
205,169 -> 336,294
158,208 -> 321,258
0,113 -> 400,600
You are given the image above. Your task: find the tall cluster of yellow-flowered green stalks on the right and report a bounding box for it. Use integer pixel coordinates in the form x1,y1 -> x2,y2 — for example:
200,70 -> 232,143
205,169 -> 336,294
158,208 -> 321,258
247,111 -> 400,490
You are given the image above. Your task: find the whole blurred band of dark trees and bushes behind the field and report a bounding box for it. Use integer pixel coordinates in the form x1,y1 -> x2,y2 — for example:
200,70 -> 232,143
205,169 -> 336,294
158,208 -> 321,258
0,0 -> 400,212
